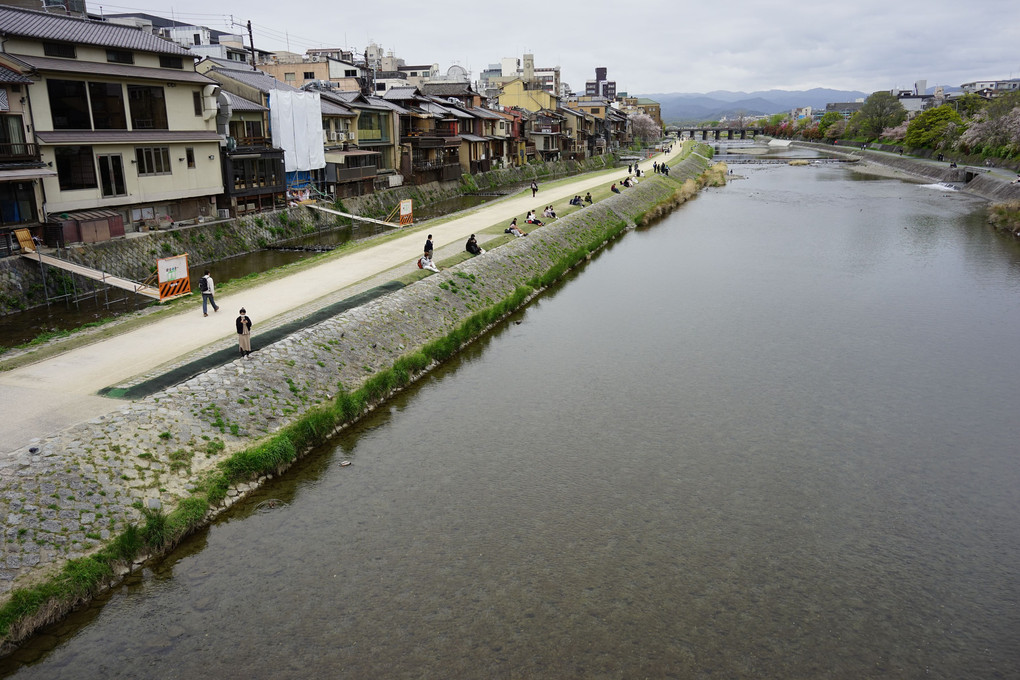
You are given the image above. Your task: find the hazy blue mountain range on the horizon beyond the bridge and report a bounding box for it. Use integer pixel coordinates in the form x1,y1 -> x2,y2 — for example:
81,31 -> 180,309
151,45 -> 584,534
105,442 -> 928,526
638,88 -> 868,123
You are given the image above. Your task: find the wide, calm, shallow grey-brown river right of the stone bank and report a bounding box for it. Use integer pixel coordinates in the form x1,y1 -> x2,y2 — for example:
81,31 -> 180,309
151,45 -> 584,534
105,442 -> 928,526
6,151 -> 1020,679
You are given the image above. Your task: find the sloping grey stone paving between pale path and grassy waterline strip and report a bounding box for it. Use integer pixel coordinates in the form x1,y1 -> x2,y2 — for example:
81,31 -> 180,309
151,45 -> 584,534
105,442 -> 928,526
0,149 -> 710,607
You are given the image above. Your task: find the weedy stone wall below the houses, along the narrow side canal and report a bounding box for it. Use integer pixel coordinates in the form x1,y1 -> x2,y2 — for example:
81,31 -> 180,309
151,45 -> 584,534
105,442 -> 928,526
0,155 -> 616,315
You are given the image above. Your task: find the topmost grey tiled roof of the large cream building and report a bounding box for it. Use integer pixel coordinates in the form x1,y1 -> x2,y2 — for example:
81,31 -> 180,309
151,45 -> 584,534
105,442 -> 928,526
0,6 -> 191,56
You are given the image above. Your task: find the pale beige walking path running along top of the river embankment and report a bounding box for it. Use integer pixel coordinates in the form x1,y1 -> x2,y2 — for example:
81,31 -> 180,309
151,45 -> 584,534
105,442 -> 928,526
0,143 -> 682,457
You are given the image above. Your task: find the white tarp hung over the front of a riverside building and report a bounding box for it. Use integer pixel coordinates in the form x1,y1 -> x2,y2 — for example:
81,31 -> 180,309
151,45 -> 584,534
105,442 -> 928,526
269,90 -> 325,172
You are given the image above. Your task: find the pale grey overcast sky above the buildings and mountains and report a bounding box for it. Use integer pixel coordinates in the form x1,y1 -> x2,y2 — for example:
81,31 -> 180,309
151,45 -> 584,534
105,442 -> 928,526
97,0 -> 1020,94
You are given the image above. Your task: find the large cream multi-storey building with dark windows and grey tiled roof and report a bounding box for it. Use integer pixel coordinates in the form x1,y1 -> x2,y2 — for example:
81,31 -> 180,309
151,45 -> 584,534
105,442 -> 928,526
0,7 -> 223,241
